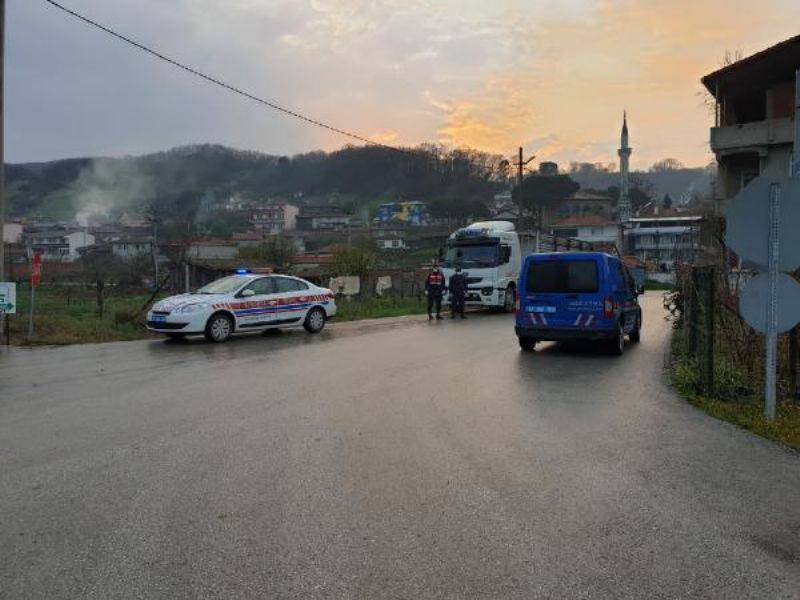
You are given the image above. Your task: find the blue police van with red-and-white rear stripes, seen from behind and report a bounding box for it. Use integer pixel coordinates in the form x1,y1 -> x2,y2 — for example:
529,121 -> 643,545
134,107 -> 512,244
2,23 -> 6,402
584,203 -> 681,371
515,252 -> 643,355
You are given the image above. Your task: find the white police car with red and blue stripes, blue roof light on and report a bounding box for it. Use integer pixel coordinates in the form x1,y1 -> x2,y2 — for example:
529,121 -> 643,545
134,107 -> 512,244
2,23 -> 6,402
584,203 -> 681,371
147,271 -> 336,342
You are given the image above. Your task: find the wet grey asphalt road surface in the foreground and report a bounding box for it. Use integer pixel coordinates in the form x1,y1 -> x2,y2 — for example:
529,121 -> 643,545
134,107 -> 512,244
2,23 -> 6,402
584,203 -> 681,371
0,295 -> 800,599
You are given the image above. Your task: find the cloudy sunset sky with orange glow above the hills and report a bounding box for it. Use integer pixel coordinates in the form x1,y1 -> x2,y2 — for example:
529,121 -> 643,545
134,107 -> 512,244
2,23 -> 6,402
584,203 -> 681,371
6,0 -> 800,168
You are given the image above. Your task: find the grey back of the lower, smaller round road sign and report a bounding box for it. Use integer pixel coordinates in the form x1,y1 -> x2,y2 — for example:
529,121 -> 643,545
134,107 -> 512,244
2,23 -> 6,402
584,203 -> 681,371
739,273 -> 800,333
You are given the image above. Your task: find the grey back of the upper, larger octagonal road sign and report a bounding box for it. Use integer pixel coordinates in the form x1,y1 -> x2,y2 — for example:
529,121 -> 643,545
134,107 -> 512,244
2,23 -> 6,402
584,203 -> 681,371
726,177 -> 800,272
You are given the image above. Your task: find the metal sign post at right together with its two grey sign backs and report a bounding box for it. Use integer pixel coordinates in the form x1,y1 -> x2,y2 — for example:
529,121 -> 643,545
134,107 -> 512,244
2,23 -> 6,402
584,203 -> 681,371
726,177 -> 800,420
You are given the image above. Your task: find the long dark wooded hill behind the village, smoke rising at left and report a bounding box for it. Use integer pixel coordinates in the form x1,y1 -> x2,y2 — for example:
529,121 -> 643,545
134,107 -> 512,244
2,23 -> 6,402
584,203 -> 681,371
6,145 -> 503,224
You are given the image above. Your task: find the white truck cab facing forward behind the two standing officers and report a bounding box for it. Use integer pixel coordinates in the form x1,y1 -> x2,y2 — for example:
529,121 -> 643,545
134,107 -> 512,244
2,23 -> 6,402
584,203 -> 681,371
441,221 -> 535,312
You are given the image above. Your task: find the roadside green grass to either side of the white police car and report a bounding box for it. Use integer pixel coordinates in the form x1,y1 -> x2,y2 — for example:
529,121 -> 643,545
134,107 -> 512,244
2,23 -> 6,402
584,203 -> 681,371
0,285 -> 432,346
